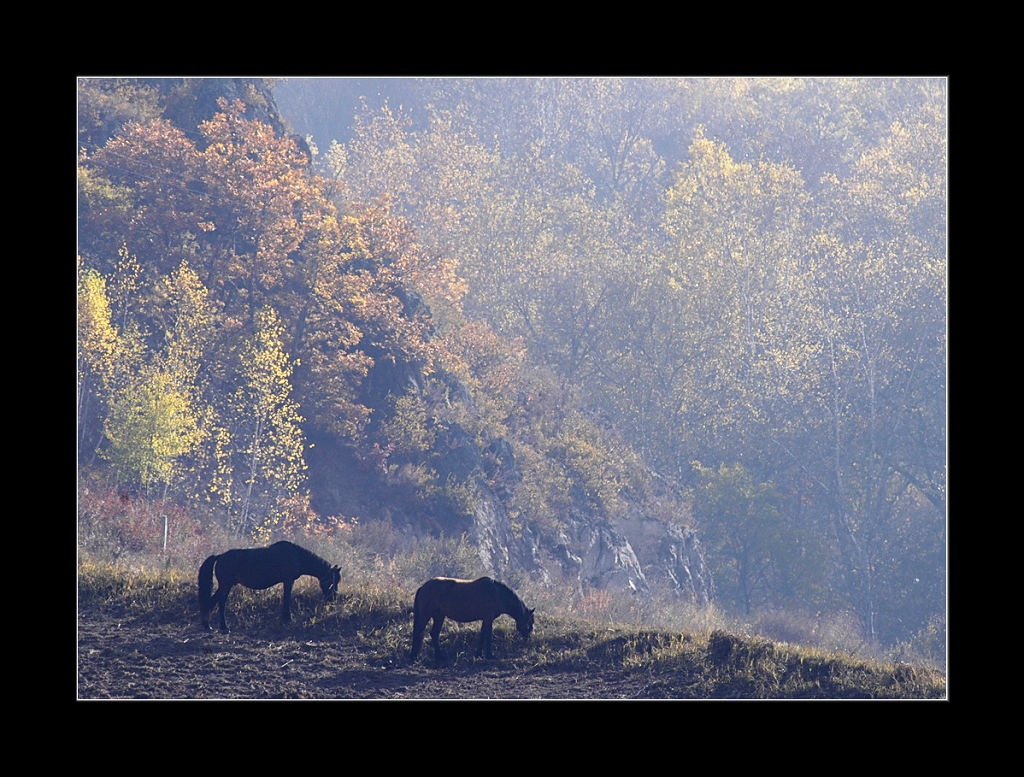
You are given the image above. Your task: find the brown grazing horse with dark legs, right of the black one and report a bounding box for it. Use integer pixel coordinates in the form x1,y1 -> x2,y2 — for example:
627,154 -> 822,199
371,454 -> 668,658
412,577 -> 534,661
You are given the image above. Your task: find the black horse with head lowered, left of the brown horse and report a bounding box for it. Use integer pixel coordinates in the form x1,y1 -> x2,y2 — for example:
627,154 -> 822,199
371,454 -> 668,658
199,541 -> 341,634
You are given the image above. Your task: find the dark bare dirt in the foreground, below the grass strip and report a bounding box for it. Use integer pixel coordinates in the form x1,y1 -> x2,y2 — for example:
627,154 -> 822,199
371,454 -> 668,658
78,610 -> 659,699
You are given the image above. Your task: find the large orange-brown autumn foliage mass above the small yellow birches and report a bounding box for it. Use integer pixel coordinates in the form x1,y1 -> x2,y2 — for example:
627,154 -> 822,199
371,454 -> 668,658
82,93 -> 461,456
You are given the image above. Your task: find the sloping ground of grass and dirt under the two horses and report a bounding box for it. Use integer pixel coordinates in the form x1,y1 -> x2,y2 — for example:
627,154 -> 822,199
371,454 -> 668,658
78,561 -> 946,699
